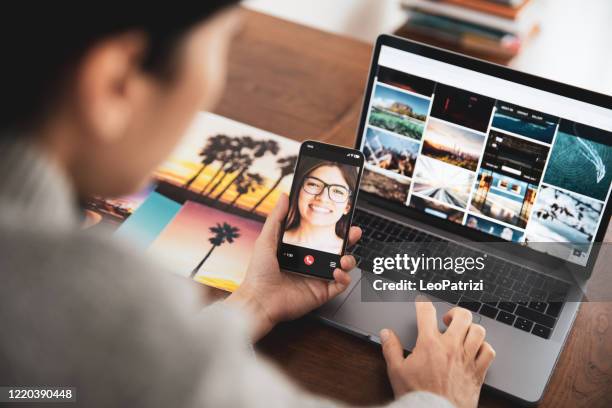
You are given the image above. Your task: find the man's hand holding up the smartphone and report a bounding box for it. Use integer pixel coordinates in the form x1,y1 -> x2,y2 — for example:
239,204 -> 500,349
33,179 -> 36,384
227,194 -> 361,341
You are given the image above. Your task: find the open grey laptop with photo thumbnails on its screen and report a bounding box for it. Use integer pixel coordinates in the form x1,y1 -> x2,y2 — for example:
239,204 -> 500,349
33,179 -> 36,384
317,35 -> 612,404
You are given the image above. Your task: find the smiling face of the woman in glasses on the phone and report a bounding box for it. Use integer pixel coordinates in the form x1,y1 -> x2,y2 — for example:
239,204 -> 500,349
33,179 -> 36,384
298,166 -> 350,230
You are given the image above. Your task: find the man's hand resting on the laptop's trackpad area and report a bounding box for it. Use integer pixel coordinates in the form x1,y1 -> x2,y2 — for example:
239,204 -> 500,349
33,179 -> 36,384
380,299 -> 495,408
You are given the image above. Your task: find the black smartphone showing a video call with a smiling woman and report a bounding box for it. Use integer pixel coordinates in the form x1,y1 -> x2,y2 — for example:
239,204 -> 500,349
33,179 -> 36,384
278,141 -> 364,280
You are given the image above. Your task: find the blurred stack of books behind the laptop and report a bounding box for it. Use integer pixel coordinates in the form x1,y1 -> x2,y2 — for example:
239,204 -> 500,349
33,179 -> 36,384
397,0 -> 541,64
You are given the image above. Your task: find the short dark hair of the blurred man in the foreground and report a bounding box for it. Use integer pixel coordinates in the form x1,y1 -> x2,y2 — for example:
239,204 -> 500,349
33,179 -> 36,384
0,0 -> 238,131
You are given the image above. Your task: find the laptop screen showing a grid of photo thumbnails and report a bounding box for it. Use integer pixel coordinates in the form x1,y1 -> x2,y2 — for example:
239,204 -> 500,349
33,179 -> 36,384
361,45 -> 612,265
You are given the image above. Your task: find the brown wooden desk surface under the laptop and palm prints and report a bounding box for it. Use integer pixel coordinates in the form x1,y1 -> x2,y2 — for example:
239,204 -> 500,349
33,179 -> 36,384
216,12 -> 612,407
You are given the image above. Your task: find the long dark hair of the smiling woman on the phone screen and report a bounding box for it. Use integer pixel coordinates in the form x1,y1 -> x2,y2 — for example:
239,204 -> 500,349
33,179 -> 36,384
285,157 -> 358,239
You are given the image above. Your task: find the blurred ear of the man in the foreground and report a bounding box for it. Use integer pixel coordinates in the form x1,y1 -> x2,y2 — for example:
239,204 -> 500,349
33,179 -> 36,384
75,32 -> 148,143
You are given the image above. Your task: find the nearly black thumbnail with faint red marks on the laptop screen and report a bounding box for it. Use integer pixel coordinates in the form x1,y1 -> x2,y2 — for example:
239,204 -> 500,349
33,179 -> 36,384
431,83 -> 495,133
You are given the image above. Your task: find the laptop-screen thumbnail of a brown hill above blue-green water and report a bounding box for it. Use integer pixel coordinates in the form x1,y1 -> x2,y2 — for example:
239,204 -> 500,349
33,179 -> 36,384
370,85 -> 430,140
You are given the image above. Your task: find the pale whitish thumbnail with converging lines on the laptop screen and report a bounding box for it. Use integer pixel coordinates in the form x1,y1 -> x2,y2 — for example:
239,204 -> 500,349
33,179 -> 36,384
413,156 -> 474,208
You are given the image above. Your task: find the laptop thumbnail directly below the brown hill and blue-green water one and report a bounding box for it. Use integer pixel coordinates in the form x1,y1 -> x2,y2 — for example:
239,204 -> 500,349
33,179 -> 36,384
362,127 -> 419,177
